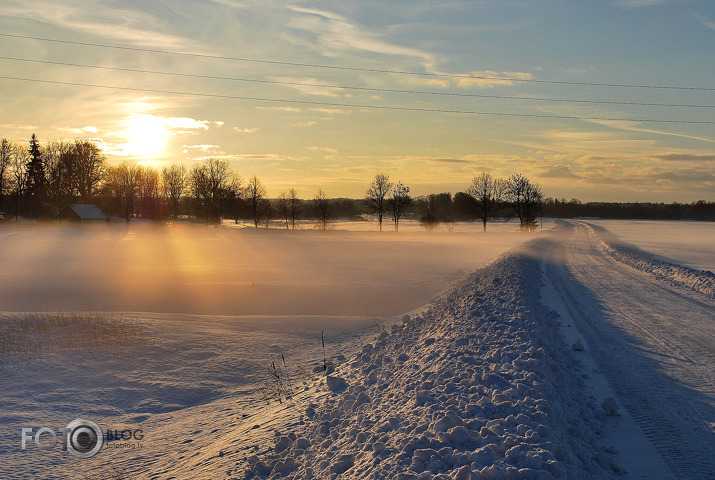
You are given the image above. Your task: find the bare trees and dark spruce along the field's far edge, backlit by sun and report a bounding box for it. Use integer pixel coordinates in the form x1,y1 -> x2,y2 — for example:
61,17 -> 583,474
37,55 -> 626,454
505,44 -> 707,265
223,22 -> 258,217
0,134 -> 543,231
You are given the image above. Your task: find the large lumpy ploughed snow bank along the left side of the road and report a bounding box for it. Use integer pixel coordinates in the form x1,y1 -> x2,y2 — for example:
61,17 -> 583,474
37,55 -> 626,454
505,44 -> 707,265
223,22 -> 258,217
238,246 -> 618,480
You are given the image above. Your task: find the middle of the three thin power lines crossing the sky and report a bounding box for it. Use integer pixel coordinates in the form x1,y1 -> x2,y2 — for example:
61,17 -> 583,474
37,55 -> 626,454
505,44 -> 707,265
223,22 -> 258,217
0,56 -> 715,108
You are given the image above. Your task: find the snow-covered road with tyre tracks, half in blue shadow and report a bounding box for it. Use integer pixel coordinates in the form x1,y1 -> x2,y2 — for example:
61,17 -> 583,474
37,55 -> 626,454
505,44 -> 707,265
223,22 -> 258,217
544,223 -> 715,478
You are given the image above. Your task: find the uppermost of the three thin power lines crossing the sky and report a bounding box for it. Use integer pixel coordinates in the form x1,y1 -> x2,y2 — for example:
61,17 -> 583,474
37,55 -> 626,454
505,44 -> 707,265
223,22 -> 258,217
0,33 -> 715,91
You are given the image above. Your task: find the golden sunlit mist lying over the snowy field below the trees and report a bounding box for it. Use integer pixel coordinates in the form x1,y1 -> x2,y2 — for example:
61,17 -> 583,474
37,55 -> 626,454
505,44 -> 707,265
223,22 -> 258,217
0,224 -> 527,316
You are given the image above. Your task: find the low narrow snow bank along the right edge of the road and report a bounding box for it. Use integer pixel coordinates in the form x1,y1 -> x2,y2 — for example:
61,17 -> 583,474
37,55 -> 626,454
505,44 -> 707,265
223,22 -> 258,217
585,223 -> 715,298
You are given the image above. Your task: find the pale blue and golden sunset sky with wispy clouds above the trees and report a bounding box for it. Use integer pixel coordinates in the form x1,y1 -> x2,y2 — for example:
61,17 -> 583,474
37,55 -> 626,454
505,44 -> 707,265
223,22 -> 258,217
0,0 -> 715,202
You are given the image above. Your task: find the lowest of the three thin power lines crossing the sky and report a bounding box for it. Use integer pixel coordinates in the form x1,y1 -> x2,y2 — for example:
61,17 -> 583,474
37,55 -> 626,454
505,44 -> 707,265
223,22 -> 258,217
0,75 -> 715,125
